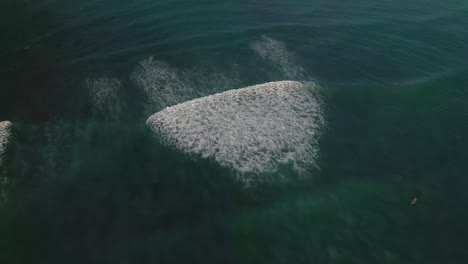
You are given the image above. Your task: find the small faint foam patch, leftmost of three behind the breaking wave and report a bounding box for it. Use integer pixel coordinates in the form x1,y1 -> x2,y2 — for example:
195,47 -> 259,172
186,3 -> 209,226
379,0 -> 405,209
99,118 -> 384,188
85,78 -> 122,118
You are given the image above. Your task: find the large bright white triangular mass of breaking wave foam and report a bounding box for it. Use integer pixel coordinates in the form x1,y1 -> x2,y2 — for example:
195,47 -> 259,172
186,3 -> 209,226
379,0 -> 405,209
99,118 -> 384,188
147,81 -> 325,179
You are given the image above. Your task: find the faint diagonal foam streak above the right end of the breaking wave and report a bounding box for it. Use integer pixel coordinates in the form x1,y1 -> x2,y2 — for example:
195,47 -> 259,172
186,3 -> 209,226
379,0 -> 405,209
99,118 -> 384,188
250,36 -> 305,79
